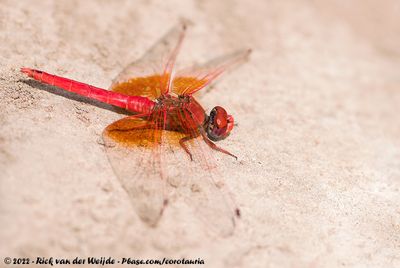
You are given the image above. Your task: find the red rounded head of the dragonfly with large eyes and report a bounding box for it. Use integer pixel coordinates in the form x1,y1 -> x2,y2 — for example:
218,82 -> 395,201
206,106 -> 234,141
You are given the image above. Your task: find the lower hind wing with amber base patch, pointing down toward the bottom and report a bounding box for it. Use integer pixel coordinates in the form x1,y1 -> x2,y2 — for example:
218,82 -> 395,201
103,112 -> 167,226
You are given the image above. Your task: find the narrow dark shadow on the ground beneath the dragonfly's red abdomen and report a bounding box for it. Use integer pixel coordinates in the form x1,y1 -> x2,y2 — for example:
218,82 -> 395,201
20,80 -> 131,115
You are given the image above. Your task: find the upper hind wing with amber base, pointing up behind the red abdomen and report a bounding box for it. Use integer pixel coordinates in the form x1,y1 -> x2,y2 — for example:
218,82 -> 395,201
110,22 -> 186,99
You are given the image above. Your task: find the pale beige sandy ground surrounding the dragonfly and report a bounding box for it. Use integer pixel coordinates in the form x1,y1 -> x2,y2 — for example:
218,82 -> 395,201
0,0 -> 400,267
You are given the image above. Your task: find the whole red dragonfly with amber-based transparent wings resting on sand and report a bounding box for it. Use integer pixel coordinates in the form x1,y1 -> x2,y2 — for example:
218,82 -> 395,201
21,24 -> 250,237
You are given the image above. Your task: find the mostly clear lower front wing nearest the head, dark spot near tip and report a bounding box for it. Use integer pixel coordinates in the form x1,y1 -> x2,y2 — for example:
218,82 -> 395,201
169,107 -> 239,236
